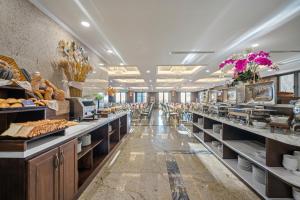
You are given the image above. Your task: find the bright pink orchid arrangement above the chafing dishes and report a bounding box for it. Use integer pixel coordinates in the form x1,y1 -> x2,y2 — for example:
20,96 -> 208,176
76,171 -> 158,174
219,51 -> 278,83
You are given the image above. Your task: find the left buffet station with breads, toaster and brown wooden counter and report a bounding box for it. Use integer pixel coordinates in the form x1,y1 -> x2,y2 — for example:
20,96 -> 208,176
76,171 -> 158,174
0,47 -> 130,200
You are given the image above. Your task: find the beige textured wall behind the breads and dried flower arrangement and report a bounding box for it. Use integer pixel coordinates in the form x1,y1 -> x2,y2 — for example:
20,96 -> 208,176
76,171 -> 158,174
0,0 -> 108,95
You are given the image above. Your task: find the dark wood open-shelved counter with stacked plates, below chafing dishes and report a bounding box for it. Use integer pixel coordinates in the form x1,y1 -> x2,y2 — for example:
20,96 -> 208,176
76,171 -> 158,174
193,112 -> 300,199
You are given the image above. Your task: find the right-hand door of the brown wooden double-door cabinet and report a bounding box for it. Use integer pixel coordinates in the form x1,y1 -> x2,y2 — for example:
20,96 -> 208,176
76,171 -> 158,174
59,139 -> 78,200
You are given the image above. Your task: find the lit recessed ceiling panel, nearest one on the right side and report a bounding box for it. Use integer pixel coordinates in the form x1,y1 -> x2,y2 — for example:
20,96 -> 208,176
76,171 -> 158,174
157,65 -> 204,75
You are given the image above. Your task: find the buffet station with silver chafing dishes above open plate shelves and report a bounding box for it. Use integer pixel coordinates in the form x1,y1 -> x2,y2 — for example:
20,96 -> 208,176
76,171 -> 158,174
191,82 -> 300,199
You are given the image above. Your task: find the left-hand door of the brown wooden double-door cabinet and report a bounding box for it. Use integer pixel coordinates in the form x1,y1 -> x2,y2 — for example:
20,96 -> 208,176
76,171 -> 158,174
27,148 -> 59,200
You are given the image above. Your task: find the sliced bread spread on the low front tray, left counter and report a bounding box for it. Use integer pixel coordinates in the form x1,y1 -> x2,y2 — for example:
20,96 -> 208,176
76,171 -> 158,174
1,119 -> 77,138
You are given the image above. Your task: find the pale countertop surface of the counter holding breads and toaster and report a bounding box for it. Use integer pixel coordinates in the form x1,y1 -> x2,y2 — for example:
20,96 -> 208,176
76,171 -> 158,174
0,112 -> 129,158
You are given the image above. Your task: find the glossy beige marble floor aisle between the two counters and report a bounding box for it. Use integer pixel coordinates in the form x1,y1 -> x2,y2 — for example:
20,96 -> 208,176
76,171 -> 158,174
80,110 -> 259,200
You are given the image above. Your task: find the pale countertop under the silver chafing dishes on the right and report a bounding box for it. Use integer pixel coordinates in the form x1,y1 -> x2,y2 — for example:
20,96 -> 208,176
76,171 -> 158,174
191,111 -> 300,147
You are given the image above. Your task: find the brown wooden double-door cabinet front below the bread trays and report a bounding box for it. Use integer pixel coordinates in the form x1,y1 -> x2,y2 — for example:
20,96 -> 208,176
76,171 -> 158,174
27,139 -> 77,200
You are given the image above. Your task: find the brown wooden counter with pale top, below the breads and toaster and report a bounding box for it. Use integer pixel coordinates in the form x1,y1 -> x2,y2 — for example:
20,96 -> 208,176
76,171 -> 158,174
0,112 -> 130,200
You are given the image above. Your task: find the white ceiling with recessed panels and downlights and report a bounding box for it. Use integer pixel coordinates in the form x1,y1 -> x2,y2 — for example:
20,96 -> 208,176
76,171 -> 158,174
30,0 -> 300,90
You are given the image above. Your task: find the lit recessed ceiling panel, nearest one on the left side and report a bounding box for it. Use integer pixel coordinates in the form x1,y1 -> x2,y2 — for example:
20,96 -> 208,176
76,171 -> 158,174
100,66 -> 141,76
